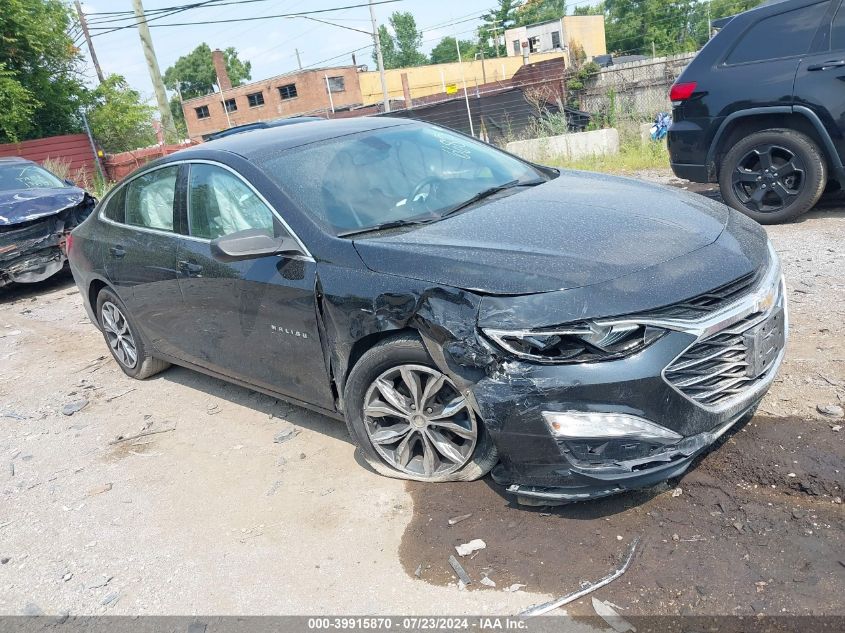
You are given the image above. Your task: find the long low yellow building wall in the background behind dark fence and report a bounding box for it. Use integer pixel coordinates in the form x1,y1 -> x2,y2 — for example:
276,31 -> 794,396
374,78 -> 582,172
358,52 -> 564,104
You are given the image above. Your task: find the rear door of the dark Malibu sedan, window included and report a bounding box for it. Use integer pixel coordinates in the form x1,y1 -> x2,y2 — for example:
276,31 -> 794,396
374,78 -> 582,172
103,165 -> 183,355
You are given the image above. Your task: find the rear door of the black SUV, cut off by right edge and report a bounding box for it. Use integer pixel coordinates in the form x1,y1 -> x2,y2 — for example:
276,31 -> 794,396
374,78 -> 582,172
795,2 -> 845,159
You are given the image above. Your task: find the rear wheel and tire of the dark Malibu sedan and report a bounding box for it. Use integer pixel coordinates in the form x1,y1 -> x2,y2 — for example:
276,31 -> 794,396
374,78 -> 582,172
97,288 -> 170,380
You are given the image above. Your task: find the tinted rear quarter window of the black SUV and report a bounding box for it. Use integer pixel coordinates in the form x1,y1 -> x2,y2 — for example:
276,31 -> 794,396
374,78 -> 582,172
727,2 -> 830,64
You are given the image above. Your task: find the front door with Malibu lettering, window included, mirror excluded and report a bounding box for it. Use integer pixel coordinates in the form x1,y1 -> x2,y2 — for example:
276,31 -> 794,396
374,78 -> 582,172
176,163 -> 334,408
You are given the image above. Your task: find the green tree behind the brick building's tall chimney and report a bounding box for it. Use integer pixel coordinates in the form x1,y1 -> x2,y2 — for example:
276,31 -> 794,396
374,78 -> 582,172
164,42 -> 252,99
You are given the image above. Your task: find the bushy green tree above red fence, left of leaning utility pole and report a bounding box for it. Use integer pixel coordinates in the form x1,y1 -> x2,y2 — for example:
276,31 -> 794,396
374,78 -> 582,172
88,75 -> 156,153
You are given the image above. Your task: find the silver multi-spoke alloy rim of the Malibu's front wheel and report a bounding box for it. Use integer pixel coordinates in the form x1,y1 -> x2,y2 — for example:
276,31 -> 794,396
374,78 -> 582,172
364,365 -> 478,479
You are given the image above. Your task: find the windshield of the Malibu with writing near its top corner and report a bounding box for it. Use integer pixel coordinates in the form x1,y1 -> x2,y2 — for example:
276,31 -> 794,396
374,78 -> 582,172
259,125 -> 548,235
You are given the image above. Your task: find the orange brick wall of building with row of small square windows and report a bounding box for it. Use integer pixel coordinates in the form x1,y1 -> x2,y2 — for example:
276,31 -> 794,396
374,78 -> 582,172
182,66 -> 360,140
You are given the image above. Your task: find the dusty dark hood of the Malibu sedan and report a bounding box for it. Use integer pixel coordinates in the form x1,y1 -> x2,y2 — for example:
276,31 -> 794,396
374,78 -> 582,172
354,171 -> 729,295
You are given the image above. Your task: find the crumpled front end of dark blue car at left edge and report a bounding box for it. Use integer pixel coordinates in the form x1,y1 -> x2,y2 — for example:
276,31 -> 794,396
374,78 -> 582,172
0,190 -> 96,287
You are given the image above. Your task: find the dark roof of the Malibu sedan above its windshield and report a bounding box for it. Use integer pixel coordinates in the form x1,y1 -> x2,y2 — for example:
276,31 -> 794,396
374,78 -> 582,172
181,116 -> 415,160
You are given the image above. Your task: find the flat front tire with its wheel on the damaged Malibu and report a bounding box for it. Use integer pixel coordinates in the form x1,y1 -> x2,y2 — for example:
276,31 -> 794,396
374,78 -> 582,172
344,334 -> 498,482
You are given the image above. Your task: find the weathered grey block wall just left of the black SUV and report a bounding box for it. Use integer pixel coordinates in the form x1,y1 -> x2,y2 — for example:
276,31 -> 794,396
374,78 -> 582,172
581,53 -> 695,121
